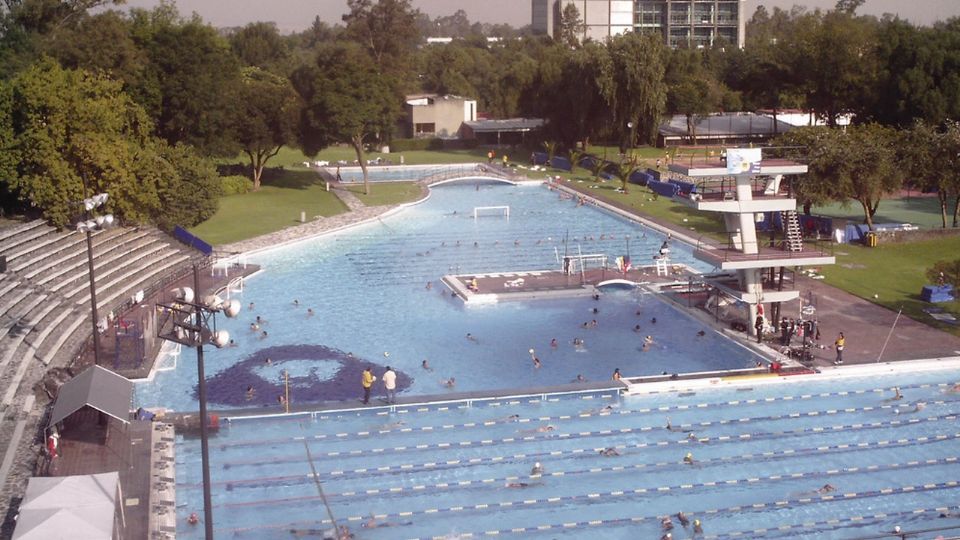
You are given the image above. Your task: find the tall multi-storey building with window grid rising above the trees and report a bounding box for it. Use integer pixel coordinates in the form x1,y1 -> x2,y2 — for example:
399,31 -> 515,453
531,0 -> 747,48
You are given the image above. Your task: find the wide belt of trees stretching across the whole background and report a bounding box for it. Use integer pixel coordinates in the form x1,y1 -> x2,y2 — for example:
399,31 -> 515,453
0,0 -> 960,229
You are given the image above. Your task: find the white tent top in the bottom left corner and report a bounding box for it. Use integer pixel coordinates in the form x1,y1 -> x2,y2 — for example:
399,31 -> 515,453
13,472 -> 120,540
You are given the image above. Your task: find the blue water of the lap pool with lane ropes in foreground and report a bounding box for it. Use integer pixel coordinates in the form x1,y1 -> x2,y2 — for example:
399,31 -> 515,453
176,370 -> 960,539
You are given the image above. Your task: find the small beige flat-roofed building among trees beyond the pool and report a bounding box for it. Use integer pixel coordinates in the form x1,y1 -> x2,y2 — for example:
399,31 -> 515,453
405,94 -> 477,139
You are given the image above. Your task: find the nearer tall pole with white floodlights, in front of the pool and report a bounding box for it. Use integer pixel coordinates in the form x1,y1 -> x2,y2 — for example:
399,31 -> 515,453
157,265 -> 240,540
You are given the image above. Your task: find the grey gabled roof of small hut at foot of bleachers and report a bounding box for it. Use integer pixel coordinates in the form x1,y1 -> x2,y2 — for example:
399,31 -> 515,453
49,366 -> 133,426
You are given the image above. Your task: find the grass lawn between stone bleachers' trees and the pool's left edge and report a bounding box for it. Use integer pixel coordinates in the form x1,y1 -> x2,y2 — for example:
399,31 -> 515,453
190,170 -> 347,245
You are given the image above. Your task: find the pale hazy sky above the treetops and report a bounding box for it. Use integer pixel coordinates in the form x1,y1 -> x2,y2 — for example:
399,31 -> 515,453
118,0 -> 960,32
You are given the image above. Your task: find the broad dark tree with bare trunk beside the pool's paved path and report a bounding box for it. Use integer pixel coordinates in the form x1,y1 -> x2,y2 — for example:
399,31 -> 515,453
293,42 -> 399,195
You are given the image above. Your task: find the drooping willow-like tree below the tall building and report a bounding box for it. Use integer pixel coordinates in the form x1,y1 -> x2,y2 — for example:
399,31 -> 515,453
607,32 -> 667,150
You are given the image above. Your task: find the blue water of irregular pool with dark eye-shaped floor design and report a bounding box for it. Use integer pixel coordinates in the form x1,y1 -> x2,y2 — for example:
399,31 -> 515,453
136,183 -> 755,410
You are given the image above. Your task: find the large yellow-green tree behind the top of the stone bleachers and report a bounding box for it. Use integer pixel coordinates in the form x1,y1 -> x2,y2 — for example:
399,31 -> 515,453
6,59 -> 219,227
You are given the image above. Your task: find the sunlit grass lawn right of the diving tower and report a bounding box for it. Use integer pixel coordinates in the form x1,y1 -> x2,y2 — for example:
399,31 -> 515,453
821,236 -> 960,335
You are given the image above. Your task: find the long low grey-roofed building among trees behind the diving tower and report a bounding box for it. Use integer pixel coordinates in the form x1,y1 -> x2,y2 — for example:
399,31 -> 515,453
657,112 -> 796,147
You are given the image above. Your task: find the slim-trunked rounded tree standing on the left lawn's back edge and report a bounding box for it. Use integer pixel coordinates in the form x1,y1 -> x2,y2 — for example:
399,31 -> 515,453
233,67 -> 302,191
